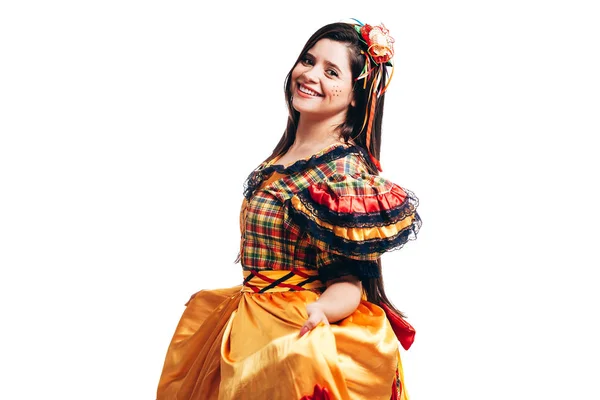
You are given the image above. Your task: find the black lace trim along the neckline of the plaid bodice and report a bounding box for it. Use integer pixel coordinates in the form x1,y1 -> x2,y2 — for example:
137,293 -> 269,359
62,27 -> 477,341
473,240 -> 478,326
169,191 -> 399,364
244,145 -> 362,200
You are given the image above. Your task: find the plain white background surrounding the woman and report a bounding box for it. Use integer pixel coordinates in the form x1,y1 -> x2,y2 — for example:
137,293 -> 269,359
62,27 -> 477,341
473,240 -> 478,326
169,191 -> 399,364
0,0 -> 600,400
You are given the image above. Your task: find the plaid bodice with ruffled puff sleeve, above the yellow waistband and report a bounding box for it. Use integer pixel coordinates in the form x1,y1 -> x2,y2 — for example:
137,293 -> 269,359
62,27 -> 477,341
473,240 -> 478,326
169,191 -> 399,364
240,144 -> 421,281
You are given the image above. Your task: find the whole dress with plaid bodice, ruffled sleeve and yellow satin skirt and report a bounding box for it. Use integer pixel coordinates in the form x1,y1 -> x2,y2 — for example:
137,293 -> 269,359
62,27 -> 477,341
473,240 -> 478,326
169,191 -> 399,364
157,144 -> 421,400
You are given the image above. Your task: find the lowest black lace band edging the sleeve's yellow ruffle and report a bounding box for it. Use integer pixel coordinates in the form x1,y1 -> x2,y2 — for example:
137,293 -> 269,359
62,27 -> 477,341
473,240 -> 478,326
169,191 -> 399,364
289,203 -> 422,256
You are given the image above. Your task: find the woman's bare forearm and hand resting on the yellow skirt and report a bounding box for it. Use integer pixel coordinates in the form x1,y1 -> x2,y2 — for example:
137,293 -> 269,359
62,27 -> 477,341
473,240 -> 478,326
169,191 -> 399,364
300,276 -> 362,336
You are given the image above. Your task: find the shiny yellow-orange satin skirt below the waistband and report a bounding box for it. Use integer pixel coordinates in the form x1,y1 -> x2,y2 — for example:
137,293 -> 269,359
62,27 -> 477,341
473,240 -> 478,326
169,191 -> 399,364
157,271 -> 408,400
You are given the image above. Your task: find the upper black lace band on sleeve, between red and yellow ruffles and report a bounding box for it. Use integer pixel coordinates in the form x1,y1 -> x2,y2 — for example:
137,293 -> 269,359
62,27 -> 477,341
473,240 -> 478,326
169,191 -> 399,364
297,189 -> 419,228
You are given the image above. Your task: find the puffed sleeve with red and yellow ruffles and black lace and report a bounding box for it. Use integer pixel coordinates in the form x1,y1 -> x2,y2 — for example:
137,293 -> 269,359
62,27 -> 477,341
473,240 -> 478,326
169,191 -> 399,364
290,173 -> 421,280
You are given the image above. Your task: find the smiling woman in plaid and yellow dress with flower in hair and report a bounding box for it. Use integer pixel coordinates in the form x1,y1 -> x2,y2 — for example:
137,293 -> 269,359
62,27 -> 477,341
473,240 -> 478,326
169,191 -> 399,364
158,21 -> 421,400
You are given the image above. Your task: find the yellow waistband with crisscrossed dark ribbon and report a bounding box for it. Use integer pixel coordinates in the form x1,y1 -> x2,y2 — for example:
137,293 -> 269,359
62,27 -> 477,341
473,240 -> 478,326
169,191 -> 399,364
242,268 -> 325,293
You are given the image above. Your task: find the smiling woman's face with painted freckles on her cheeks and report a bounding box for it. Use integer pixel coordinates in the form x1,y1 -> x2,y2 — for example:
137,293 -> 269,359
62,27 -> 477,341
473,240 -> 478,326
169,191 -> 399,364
291,39 -> 354,123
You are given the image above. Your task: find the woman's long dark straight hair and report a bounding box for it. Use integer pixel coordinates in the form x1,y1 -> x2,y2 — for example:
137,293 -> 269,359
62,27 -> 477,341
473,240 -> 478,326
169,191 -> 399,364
265,22 -> 404,317
